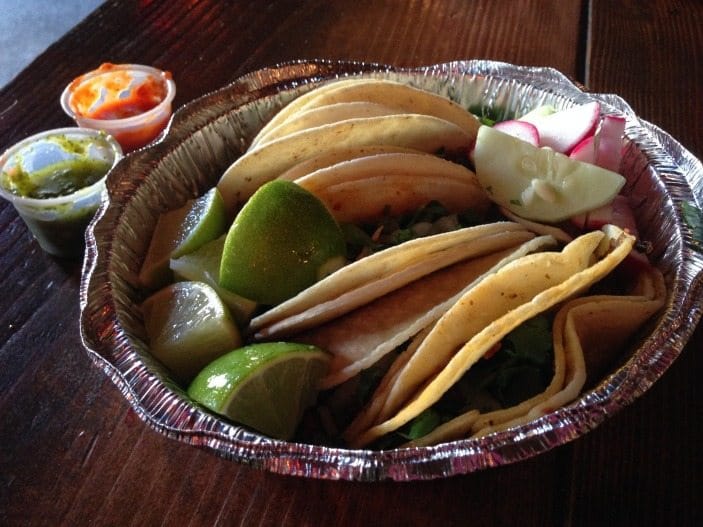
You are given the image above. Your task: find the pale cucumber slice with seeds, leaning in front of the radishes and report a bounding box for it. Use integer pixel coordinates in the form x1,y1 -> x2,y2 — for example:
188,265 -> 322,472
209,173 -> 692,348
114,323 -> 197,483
473,126 -> 625,222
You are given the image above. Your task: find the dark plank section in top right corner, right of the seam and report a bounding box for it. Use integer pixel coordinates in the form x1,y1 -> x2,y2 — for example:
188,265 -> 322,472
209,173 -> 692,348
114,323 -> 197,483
586,0 -> 703,157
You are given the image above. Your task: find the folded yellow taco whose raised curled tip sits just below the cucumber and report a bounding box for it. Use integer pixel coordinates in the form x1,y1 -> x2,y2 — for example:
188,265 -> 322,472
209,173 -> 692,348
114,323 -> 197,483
345,226 -> 635,447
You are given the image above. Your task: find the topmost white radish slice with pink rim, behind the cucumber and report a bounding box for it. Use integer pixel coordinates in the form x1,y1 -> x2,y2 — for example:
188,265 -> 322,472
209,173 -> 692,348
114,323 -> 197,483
523,101 -> 600,154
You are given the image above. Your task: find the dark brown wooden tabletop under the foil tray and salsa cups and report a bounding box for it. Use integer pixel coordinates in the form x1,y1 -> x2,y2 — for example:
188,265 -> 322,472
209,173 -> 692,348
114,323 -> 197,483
0,0 -> 703,526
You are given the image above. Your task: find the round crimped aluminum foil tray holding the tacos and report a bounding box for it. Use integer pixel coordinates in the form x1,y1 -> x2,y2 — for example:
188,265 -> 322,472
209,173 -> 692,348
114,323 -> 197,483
80,60 -> 703,481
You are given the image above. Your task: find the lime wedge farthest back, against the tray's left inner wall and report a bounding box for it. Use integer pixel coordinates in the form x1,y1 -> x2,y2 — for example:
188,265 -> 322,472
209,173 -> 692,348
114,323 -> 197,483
139,188 -> 227,288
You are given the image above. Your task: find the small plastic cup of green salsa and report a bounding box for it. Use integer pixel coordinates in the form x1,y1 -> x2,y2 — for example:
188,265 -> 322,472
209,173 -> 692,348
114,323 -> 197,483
0,128 -> 122,258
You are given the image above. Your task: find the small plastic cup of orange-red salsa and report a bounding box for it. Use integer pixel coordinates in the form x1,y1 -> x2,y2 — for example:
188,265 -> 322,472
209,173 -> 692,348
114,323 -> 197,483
61,63 -> 176,152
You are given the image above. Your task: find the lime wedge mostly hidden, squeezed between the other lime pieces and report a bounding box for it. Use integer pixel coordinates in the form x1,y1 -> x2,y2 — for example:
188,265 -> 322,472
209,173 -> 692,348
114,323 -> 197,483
170,235 -> 256,327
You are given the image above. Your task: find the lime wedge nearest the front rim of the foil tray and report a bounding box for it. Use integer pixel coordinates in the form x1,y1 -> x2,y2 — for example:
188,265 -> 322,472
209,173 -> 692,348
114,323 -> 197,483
188,342 -> 330,440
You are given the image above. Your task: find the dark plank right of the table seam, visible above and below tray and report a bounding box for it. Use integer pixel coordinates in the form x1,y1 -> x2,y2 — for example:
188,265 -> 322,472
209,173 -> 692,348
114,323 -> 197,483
569,0 -> 703,525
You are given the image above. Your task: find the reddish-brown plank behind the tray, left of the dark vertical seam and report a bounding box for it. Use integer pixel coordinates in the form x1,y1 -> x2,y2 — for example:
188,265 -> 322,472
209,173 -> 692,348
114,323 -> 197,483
239,0 -> 581,76
